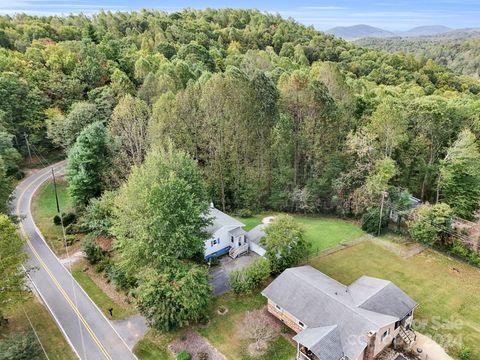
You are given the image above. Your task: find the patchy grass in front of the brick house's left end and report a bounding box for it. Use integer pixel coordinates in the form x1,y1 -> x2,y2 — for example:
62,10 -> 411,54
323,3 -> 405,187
198,293 -> 296,360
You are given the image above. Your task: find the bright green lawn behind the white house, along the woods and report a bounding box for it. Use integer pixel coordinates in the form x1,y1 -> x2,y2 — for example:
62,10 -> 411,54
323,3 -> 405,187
238,214 -> 365,255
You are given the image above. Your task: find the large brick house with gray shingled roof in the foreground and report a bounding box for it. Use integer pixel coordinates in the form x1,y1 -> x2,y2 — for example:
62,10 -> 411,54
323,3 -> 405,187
262,266 -> 417,360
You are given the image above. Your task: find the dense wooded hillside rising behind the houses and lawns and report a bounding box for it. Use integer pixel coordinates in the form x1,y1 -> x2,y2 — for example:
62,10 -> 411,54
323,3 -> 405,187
0,9 -> 480,217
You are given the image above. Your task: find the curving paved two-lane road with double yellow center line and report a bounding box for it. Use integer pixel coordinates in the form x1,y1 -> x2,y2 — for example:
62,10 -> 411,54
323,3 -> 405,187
14,163 -> 136,360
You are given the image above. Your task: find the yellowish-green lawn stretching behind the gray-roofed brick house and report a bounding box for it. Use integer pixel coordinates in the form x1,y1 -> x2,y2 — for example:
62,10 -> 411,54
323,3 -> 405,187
311,241 -> 480,359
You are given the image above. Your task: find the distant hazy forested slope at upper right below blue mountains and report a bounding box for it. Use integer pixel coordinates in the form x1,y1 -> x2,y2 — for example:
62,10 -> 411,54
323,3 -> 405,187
355,34 -> 480,79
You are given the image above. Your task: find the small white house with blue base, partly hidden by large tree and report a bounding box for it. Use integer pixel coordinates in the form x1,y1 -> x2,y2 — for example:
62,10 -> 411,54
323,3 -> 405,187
204,204 -> 265,261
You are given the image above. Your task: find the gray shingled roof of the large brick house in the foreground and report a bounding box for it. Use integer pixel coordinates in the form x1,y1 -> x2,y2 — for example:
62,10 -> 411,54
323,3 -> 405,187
262,266 -> 416,360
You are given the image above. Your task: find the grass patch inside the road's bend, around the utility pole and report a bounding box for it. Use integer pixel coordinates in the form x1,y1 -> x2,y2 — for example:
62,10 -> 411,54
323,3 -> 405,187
32,178 -> 73,255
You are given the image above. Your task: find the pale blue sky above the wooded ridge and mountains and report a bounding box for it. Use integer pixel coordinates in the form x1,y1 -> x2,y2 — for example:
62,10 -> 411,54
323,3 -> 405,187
0,0 -> 480,30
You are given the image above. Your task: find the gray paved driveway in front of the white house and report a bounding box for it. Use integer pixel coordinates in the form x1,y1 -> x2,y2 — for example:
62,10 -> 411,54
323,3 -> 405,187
209,252 -> 259,296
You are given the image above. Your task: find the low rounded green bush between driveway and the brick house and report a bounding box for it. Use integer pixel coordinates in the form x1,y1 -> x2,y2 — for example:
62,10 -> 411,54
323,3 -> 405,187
230,258 -> 270,294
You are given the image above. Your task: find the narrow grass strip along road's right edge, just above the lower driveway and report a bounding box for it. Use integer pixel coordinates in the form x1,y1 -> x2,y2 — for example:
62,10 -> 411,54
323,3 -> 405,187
72,265 -> 137,320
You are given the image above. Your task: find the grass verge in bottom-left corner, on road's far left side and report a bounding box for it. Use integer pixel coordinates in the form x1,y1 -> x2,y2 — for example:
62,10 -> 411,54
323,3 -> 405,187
0,296 -> 77,360
